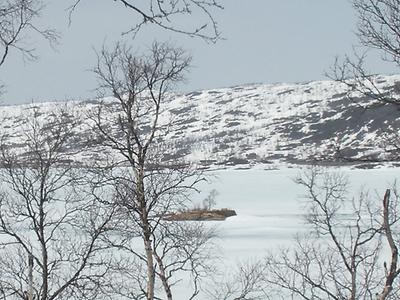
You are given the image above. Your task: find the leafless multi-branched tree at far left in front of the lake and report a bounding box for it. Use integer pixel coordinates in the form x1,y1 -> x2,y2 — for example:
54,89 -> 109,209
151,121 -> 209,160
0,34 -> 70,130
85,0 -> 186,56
0,106 -> 113,300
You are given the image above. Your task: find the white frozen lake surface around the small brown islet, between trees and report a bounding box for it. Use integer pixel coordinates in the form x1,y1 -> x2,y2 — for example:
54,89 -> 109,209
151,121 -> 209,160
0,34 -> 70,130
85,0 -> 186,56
192,167 -> 400,261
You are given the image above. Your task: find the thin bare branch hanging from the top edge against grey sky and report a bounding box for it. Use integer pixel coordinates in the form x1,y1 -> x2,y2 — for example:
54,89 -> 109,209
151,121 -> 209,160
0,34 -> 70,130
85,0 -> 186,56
70,0 -> 223,42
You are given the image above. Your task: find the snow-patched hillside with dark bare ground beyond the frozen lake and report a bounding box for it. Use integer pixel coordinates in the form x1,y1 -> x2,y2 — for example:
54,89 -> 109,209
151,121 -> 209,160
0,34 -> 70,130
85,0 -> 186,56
0,75 -> 400,167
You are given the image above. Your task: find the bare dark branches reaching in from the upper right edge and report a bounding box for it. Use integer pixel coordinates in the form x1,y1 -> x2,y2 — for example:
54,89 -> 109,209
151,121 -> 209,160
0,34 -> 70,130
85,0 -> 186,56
327,0 -> 400,160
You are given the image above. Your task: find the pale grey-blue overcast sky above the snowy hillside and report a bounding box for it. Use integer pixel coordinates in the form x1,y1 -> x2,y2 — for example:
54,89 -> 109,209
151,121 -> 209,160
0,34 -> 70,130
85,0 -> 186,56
0,0 -> 396,104
